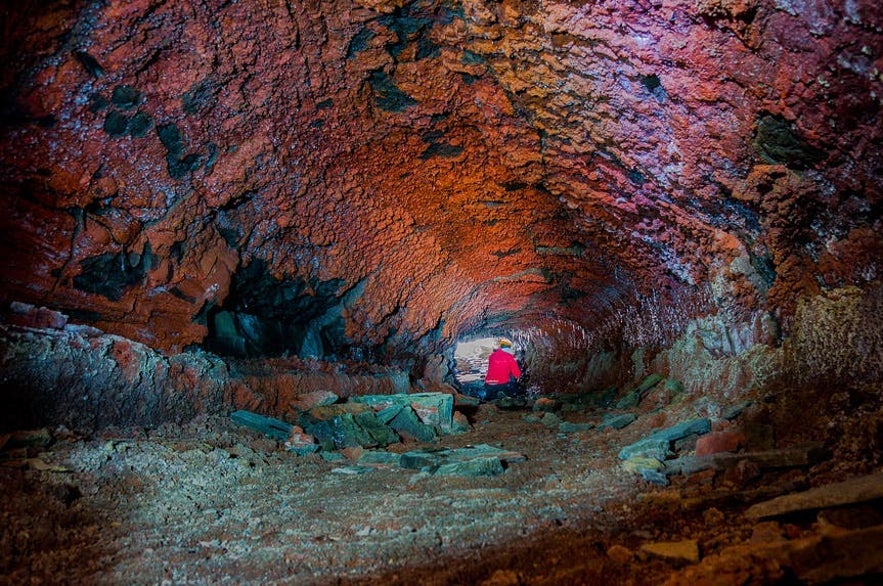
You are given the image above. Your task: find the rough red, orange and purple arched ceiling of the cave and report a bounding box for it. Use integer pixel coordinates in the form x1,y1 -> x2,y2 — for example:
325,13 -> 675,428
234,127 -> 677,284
0,0 -> 883,360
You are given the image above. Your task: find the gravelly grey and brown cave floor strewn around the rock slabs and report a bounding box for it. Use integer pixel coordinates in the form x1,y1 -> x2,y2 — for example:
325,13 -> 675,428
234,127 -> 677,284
0,392 -> 880,585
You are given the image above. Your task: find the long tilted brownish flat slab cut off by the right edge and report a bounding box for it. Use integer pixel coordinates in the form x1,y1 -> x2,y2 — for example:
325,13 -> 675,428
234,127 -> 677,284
745,472 -> 883,519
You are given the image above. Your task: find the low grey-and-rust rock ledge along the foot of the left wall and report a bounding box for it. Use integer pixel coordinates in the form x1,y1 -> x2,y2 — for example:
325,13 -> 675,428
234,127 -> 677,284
0,318 -> 409,432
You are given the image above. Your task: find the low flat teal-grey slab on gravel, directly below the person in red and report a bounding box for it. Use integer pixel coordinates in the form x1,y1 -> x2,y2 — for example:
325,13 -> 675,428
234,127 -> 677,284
399,444 -> 526,476
